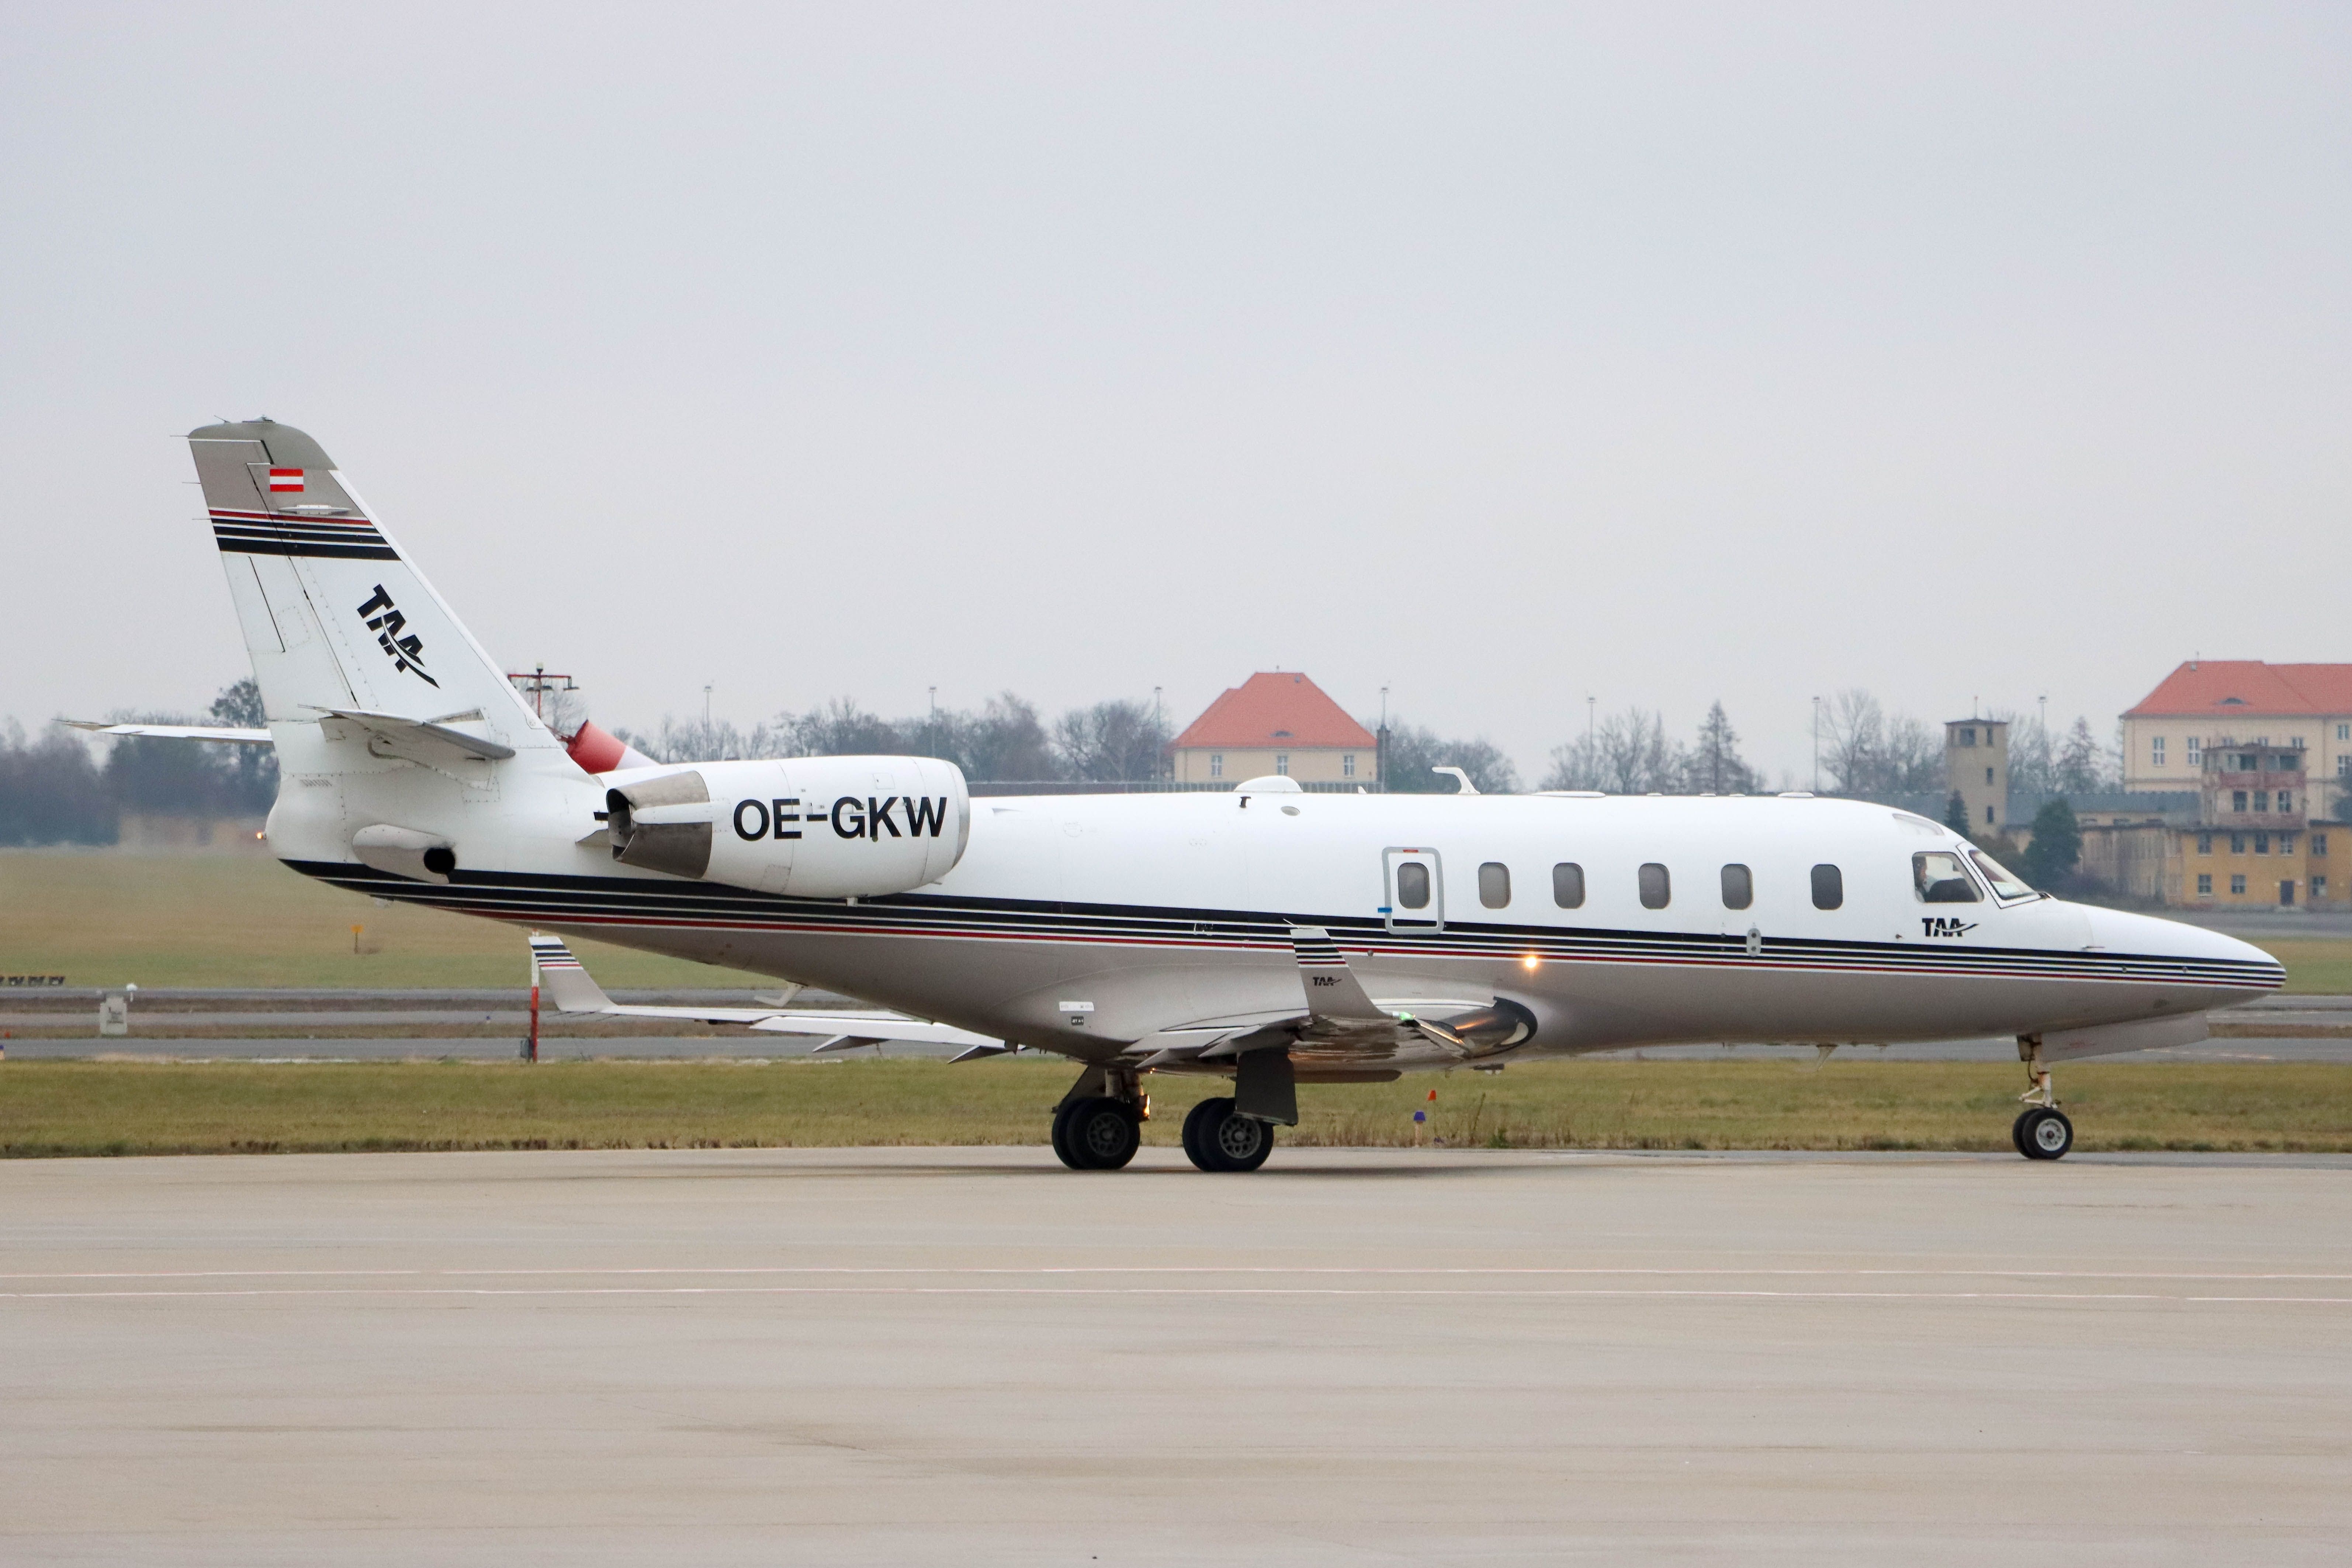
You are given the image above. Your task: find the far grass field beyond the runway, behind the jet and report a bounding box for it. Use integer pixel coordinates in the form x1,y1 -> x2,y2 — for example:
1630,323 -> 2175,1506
14,851 -> 2352,994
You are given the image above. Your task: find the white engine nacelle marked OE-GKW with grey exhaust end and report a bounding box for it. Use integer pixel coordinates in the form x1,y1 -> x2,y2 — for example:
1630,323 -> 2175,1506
605,757 -> 971,898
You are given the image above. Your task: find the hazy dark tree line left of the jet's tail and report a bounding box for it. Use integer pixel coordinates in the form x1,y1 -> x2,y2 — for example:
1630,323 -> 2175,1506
0,679 -> 277,846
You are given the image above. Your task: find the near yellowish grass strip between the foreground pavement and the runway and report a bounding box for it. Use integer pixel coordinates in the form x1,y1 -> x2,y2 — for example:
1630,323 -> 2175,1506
0,1060 -> 2352,1157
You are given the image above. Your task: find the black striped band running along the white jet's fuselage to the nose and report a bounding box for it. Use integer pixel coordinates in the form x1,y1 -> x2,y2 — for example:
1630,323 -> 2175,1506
270,861 -> 2284,990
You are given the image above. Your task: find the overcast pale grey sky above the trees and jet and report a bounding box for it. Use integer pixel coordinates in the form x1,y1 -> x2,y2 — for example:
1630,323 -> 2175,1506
0,0 -> 2352,773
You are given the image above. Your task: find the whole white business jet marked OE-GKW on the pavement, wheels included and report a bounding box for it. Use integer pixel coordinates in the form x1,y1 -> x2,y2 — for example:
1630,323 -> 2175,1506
83,421 -> 2284,1171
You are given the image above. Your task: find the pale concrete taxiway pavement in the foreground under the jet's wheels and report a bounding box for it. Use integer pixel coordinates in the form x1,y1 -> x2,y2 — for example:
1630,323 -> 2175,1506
0,1150 -> 2352,1566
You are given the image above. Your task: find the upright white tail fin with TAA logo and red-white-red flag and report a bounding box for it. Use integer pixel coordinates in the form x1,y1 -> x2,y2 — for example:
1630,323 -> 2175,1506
188,418 -> 553,745
